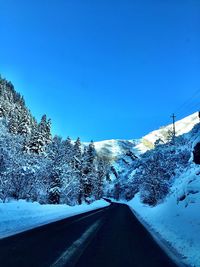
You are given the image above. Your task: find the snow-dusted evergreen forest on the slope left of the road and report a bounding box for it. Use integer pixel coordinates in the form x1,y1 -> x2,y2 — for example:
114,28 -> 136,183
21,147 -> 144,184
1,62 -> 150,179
0,78 -> 109,205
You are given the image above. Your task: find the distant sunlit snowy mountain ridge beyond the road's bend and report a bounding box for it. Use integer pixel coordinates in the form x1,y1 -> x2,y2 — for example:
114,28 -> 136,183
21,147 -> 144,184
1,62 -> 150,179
94,112 -> 199,194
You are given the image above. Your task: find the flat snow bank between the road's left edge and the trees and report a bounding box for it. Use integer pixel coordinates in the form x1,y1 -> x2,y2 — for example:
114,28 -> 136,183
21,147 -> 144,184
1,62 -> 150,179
0,200 -> 109,238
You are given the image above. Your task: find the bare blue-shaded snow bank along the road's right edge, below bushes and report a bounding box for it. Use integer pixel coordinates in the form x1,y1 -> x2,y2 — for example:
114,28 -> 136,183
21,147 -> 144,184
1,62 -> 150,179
128,165 -> 200,267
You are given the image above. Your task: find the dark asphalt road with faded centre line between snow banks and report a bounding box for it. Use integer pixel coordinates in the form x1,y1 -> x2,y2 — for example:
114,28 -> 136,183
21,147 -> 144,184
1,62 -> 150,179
0,203 -> 176,267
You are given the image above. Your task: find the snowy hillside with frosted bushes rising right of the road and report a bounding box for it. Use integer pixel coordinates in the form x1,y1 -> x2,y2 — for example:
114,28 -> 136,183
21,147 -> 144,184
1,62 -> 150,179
124,116 -> 200,267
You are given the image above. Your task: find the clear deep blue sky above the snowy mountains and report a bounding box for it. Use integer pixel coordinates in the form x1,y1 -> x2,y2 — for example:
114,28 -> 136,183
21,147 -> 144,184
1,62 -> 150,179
0,0 -> 200,141
